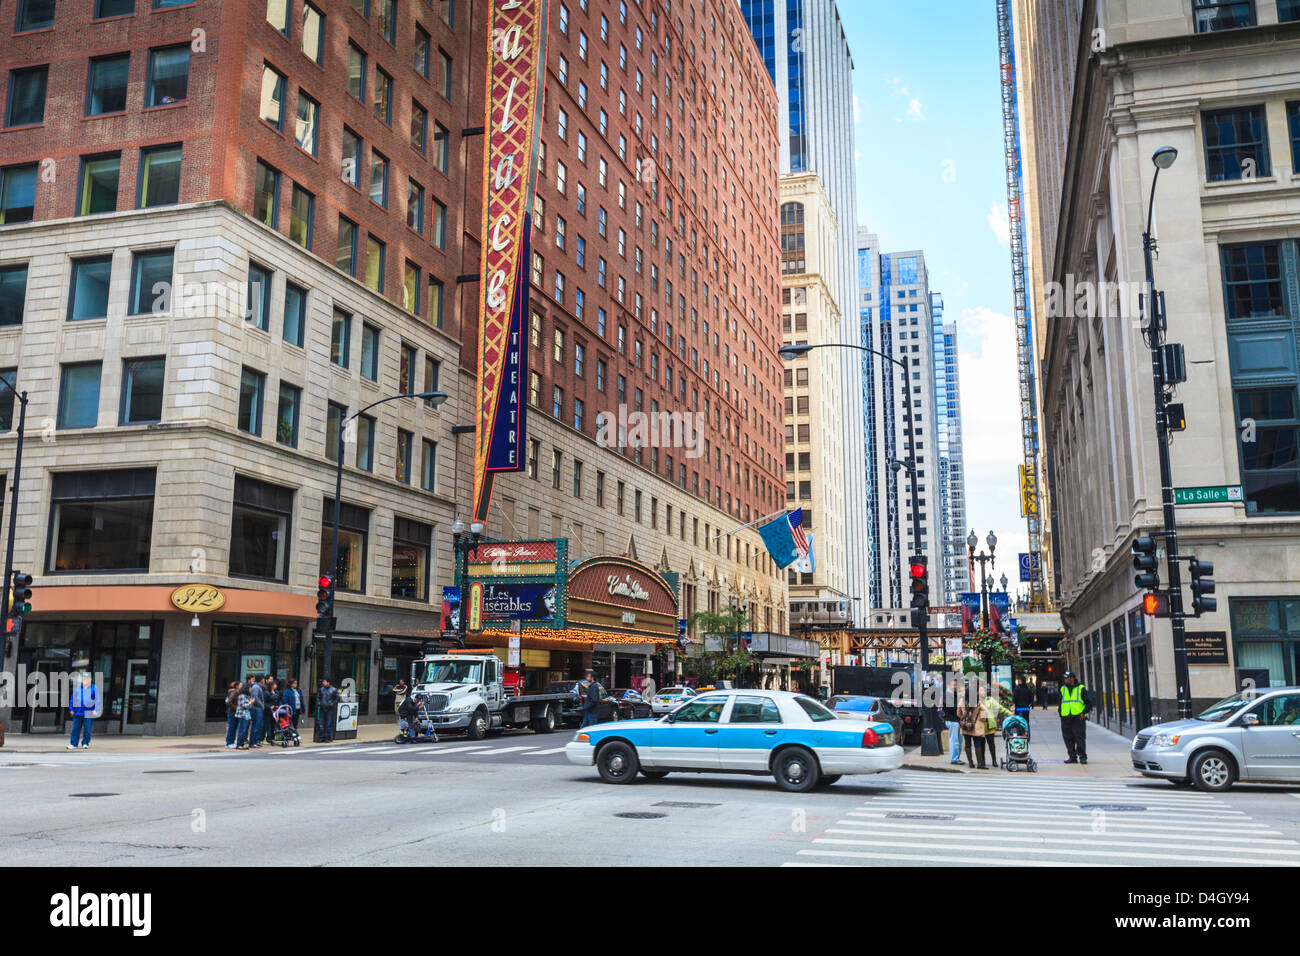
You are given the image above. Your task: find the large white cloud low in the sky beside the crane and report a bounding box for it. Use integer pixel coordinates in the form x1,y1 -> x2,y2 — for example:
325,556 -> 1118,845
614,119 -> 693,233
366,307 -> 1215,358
957,306 -> 1028,567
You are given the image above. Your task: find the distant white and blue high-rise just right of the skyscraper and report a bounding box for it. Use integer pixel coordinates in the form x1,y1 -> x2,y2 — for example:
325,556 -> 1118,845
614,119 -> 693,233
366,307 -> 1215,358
855,228 -> 956,609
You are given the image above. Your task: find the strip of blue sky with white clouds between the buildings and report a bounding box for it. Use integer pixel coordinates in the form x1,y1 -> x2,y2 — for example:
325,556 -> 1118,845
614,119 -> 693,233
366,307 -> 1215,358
839,0 -> 1027,592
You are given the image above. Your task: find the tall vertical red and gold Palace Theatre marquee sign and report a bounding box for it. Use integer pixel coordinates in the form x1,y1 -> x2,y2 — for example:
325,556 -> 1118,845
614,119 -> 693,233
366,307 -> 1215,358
473,0 -> 546,522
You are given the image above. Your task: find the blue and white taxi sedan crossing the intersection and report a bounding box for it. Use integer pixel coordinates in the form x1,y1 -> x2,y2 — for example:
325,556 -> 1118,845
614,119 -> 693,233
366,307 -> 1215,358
564,689 -> 902,792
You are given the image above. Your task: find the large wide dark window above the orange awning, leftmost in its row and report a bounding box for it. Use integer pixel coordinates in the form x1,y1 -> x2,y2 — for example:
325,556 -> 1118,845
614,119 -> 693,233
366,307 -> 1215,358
46,468 -> 155,574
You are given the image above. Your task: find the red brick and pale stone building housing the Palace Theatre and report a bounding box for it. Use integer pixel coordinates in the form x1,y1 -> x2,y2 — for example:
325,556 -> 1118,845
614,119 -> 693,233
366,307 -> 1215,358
0,0 -> 787,734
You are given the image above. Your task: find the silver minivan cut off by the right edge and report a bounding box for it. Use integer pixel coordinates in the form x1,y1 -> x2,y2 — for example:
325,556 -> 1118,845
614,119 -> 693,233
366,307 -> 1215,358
1131,687 -> 1300,792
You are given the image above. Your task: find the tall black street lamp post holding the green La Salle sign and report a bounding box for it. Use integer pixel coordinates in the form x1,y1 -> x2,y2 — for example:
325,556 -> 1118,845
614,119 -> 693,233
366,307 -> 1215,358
1141,146 -> 1192,719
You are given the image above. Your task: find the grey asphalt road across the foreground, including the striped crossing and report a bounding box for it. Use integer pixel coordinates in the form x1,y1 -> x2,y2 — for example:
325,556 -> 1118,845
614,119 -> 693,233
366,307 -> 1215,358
0,734 -> 1300,866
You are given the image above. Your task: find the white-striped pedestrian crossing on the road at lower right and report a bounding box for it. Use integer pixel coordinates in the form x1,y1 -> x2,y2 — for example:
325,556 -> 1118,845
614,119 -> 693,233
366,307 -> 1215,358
785,771 -> 1300,866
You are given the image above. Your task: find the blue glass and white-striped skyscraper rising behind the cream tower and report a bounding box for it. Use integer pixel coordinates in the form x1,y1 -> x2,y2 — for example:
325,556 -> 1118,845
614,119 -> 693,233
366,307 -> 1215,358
740,0 -> 870,621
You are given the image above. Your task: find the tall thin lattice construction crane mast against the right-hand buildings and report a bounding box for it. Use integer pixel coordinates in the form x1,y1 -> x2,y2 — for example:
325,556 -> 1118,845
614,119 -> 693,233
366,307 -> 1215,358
997,0 -> 1045,610
